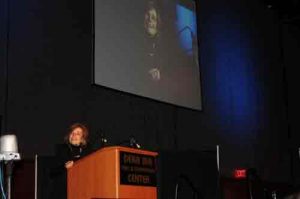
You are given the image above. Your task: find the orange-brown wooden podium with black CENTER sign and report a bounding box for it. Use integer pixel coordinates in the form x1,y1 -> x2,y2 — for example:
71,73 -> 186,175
67,146 -> 158,199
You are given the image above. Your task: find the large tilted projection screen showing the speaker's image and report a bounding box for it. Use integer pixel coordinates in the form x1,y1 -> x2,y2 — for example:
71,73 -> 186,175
94,0 -> 201,110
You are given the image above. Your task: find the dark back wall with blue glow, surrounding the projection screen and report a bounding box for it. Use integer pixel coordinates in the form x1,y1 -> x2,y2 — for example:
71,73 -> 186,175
0,0 -> 290,181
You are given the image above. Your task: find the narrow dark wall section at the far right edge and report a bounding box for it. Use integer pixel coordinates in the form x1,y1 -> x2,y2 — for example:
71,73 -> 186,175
281,18 -> 300,186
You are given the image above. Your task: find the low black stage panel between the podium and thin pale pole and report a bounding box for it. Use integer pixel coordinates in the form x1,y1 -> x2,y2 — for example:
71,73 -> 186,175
157,149 -> 221,199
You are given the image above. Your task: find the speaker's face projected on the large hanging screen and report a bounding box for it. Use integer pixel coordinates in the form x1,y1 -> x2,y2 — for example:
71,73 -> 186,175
144,1 -> 160,37
